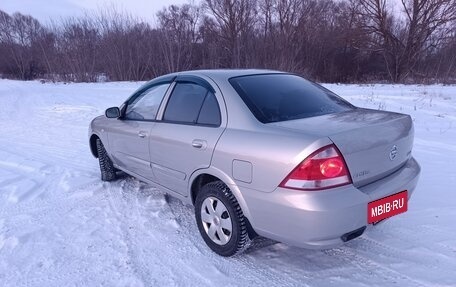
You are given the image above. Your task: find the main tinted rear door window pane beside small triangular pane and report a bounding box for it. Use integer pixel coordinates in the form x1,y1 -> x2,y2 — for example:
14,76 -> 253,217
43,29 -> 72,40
163,82 -> 212,124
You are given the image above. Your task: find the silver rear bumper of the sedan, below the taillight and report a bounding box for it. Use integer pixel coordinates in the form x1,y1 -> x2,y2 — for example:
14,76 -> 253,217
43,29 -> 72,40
241,158 -> 420,249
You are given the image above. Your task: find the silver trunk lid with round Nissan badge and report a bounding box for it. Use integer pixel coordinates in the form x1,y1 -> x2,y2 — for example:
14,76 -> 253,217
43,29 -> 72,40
270,108 -> 414,187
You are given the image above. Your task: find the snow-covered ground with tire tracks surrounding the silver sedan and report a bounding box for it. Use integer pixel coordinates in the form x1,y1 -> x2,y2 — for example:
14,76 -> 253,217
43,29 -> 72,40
0,80 -> 456,286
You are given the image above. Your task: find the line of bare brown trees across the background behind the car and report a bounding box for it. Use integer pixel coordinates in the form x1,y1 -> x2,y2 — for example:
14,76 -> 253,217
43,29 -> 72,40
0,0 -> 456,82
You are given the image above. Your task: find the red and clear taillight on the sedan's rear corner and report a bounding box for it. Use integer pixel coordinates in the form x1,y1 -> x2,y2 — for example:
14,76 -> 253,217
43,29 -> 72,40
280,144 -> 351,190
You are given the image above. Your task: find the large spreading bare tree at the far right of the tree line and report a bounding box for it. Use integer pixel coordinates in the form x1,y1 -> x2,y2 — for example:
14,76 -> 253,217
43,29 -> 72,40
357,0 -> 456,82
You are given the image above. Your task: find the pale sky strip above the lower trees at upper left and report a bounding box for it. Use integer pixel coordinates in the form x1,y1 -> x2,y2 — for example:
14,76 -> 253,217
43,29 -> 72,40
0,0 -> 188,24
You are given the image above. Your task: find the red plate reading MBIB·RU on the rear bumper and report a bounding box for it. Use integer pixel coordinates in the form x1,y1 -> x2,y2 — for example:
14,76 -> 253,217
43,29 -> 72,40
367,190 -> 407,224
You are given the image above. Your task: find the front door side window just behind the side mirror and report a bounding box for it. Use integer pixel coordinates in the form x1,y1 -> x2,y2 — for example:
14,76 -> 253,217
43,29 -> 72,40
124,83 -> 170,120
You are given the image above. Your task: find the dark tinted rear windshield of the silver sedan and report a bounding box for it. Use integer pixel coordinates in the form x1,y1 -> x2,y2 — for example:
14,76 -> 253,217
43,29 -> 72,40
229,74 -> 354,123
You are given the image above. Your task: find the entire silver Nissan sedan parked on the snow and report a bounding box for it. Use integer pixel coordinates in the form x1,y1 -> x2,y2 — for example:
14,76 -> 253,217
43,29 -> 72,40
89,70 -> 420,256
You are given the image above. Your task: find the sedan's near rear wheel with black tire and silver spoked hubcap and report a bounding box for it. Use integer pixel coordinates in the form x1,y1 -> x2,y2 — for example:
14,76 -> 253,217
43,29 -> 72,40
195,181 -> 249,256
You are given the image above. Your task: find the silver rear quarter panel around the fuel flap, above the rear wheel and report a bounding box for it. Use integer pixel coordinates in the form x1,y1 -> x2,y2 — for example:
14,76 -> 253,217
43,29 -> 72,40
212,126 -> 332,192
